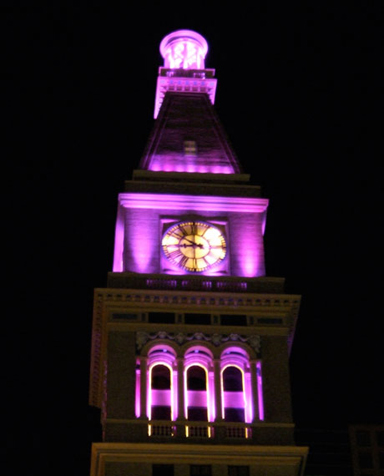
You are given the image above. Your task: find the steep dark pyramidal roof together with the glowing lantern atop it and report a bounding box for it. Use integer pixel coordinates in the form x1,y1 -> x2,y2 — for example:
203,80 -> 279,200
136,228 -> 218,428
139,30 -> 242,174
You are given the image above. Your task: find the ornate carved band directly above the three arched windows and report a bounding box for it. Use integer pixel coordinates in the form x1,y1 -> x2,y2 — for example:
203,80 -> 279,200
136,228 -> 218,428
136,331 -> 261,354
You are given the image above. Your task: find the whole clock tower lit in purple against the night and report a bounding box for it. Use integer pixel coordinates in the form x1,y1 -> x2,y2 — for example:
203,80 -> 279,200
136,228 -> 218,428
90,30 -> 308,476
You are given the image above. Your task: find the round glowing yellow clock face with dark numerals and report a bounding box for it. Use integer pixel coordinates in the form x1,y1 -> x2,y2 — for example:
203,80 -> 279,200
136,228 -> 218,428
161,221 -> 226,273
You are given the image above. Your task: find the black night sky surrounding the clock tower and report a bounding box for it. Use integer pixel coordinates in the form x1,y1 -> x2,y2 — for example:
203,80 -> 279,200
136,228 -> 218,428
2,2 -> 384,475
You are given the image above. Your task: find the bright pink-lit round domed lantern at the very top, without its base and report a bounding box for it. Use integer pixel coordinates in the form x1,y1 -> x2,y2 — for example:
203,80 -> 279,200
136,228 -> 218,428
160,30 -> 208,69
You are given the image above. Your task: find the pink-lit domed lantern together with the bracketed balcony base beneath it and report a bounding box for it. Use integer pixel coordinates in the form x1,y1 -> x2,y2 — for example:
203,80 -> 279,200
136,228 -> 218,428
154,30 -> 217,119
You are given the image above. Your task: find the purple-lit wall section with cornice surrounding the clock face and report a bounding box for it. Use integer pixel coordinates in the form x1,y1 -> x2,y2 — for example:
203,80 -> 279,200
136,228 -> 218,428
113,193 -> 268,277
